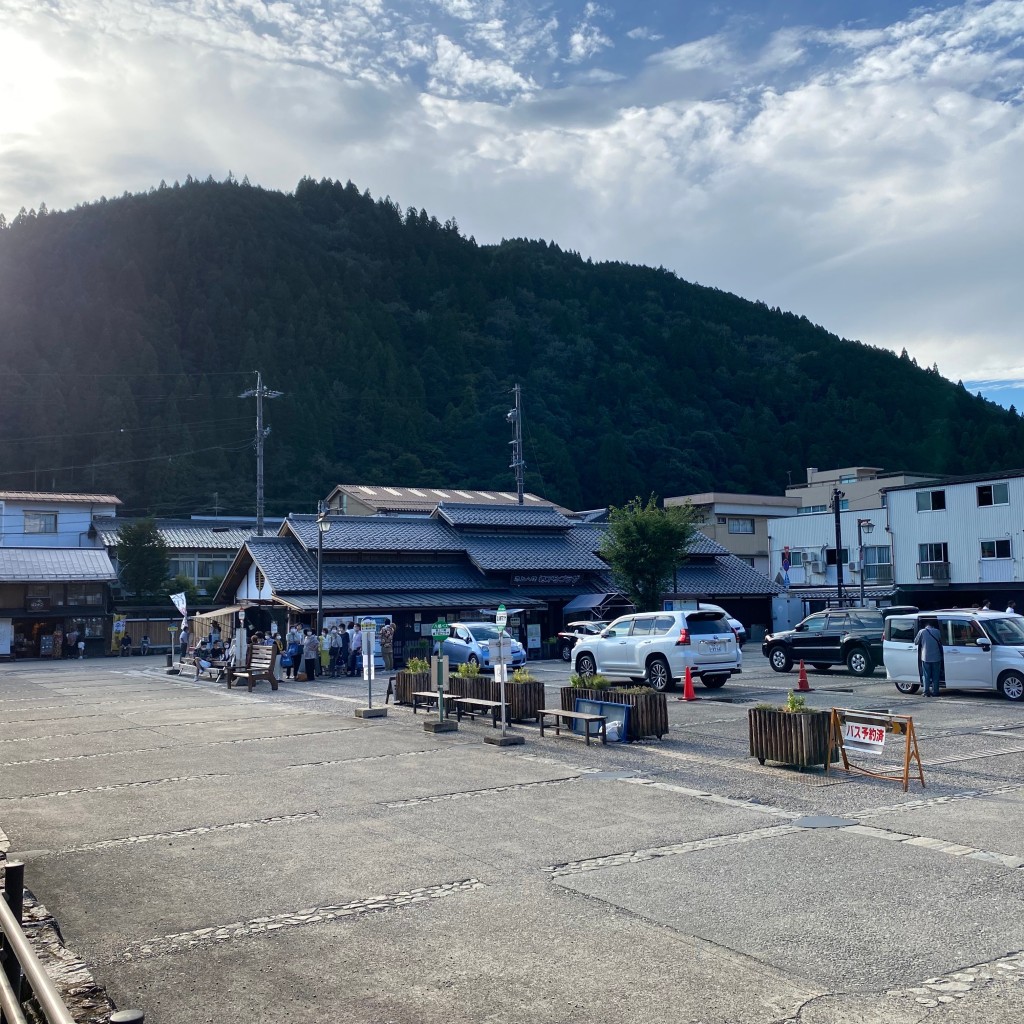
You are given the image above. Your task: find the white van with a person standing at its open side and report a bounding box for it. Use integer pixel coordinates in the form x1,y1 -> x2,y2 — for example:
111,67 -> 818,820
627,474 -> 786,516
882,608 -> 1024,700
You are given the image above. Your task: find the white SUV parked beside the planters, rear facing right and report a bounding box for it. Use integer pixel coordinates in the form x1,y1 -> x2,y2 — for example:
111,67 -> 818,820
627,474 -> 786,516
572,609 -> 743,691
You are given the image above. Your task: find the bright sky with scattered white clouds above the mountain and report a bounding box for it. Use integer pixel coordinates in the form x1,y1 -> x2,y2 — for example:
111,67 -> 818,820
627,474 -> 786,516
0,0 -> 1024,410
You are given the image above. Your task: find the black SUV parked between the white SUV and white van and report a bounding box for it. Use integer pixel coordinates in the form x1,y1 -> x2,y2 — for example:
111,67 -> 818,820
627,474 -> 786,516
761,608 -> 890,676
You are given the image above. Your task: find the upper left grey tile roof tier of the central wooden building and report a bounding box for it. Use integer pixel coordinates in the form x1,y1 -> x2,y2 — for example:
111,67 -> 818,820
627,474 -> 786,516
282,515 -> 466,551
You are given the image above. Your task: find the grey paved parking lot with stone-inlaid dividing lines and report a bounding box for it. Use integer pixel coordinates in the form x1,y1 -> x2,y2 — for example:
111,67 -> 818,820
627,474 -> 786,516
0,645 -> 1024,1024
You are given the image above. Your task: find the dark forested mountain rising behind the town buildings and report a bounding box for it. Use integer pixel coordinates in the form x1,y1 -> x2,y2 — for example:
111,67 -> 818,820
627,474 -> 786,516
0,179 -> 1024,515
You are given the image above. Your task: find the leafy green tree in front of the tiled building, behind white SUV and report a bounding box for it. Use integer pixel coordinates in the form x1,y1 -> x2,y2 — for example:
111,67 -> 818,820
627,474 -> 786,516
600,495 -> 693,611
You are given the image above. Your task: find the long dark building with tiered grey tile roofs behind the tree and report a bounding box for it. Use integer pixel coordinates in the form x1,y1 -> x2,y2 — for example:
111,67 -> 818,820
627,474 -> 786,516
217,501 -> 780,657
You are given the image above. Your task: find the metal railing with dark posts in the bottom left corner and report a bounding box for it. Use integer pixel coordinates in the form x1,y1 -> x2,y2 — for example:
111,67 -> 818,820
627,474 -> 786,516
0,860 -> 145,1024
